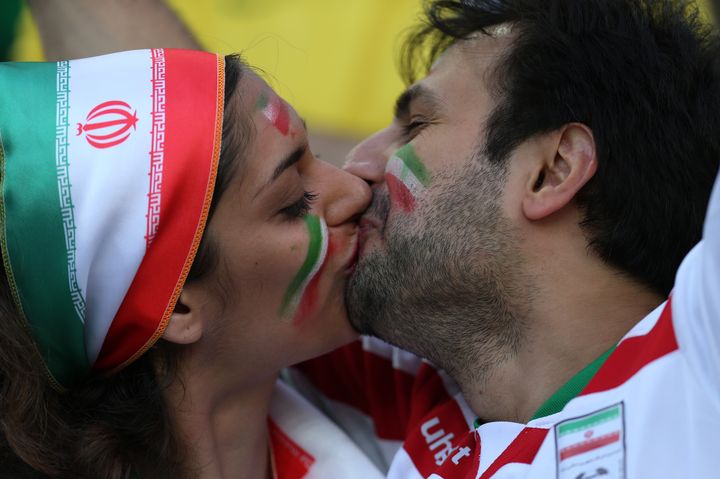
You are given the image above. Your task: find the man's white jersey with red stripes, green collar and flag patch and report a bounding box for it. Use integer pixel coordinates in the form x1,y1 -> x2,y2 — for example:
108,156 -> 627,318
293,171 -> 720,479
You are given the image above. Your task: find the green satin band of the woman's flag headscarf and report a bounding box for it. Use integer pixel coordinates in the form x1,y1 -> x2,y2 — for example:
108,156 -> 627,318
0,63 -> 90,385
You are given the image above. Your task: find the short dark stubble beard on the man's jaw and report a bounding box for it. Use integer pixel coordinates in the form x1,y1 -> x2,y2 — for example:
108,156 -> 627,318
346,160 -> 529,382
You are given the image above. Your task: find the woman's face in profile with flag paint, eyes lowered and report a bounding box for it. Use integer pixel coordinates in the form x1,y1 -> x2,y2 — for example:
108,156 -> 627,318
184,71 -> 370,374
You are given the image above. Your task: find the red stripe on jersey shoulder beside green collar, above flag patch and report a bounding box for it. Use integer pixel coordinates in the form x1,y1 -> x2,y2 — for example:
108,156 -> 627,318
580,299 -> 678,396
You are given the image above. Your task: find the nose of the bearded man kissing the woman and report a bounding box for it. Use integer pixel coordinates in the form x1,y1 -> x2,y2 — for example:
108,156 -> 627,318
344,127 -> 398,186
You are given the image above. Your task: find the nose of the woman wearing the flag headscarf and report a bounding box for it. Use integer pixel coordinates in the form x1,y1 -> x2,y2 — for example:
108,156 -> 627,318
321,164 -> 372,226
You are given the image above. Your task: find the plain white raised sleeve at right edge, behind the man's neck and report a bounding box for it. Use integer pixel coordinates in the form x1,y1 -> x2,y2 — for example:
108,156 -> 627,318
672,170 -> 720,397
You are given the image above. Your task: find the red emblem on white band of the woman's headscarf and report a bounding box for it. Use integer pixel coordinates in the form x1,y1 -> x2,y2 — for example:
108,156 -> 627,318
77,100 -> 138,148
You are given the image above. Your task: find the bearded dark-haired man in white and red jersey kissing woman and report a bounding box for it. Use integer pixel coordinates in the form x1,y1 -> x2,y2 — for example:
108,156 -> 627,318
25,0 -> 720,479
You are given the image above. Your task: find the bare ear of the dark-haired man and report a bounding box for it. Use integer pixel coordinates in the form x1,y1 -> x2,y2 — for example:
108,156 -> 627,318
522,123 -> 597,221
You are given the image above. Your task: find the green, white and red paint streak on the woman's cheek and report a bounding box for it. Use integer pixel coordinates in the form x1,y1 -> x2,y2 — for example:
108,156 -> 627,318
280,215 -> 329,322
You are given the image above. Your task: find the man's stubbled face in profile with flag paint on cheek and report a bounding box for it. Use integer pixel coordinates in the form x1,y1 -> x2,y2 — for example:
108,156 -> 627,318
346,37 -> 520,374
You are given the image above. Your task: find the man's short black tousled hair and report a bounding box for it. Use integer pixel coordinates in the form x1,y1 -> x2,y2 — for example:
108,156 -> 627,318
402,0 -> 720,295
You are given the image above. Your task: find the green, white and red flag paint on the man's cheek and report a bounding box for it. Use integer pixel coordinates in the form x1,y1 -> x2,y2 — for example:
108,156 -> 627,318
385,144 -> 430,213
